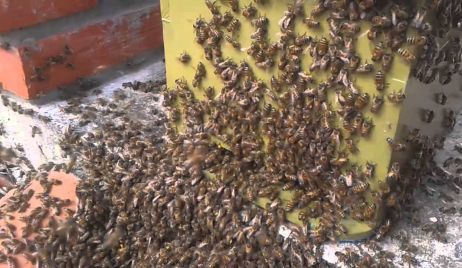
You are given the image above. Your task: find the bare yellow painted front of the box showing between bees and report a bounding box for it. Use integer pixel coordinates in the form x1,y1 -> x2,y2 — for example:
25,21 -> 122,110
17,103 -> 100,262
161,0 -> 420,240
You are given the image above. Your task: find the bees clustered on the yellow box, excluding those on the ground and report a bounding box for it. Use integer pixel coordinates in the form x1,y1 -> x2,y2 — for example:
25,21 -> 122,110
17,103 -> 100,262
164,0 -> 455,242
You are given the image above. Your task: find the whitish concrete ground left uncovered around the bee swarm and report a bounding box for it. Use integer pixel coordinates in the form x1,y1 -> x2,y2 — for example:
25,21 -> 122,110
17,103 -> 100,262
0,52 -> 462,267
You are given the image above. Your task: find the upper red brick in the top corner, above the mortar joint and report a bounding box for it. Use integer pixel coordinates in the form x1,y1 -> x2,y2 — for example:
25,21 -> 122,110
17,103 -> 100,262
0,0 -> 98,33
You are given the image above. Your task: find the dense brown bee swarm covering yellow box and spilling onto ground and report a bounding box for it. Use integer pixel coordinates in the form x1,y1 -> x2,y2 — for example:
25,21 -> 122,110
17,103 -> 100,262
0,0 -> 454,267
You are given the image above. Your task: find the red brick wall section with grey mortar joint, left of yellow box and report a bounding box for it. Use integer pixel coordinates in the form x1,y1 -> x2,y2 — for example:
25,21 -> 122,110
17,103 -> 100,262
0,0 -> 162,99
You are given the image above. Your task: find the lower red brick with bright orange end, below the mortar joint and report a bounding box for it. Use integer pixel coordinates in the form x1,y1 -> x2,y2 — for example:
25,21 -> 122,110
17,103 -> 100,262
0,5 -> 163,99
